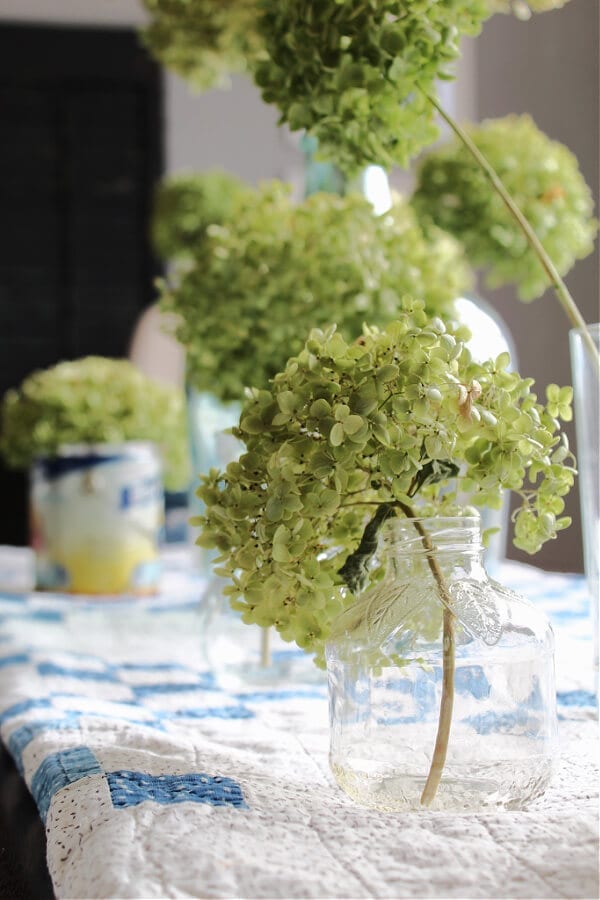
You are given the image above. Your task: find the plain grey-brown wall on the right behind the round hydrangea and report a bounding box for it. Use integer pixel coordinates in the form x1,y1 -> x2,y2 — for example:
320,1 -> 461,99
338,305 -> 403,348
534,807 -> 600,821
470,0 -> 600,570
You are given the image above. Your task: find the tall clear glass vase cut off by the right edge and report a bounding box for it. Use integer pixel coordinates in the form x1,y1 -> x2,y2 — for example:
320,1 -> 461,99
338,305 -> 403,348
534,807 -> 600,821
569,324 -> 600,669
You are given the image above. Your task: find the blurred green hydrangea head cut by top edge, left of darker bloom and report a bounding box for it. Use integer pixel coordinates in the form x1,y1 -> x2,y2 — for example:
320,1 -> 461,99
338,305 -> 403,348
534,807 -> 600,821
141,0 -> 262,89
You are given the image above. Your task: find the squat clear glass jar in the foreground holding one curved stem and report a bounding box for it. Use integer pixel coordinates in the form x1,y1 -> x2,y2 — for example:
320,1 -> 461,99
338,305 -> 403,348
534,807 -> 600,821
326,518 -> 557,811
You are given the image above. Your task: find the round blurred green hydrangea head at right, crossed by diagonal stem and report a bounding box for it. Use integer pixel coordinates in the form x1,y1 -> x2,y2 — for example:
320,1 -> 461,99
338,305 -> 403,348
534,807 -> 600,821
411,115 -> 597,300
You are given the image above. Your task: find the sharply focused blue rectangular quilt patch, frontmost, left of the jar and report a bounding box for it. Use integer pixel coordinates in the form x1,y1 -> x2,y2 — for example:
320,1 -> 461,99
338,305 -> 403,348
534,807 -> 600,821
106,770 -> 248,809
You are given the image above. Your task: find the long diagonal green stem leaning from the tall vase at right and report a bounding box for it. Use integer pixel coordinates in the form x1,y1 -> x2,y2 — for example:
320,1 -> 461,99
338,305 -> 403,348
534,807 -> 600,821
421,89 -> 600,374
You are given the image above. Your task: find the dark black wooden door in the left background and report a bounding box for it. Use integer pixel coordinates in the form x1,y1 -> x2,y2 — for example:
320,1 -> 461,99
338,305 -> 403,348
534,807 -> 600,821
0,25 -> 162,543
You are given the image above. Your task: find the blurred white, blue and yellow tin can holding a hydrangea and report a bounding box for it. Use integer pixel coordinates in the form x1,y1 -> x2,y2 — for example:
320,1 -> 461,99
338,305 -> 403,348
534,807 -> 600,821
30,441 -> 164,594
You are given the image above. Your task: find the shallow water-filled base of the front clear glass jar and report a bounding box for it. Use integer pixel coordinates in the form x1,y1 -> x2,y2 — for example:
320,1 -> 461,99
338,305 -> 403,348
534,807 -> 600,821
330,757 -> 553,812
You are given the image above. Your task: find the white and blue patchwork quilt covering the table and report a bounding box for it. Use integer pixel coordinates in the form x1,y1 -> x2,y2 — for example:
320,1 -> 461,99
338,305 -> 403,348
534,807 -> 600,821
0,548 -> 598,898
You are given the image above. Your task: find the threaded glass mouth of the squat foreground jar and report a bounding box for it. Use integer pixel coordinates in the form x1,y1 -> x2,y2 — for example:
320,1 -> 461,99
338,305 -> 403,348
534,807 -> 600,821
382,515 -> 482,552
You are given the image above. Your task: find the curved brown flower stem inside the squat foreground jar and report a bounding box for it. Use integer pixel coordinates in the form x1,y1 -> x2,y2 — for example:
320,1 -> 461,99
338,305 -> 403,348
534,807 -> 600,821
398,501 -> 456,806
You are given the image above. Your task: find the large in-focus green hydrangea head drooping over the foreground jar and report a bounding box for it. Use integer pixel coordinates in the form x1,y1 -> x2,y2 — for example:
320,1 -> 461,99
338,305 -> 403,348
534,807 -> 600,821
197,306 -> 574,659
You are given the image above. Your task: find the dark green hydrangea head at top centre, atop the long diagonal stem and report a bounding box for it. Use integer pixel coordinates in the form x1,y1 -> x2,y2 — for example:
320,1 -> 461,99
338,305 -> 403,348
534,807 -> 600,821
254,0 -> 490,172
